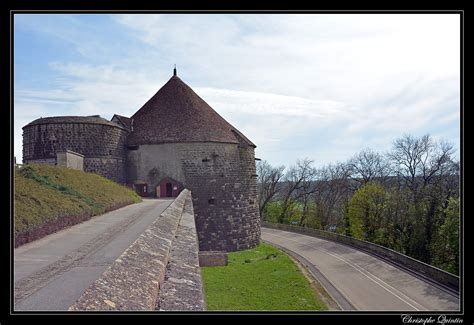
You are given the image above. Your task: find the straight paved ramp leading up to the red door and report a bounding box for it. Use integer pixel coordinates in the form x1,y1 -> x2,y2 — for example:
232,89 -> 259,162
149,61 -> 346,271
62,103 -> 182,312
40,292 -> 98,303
14,199 -> 172,311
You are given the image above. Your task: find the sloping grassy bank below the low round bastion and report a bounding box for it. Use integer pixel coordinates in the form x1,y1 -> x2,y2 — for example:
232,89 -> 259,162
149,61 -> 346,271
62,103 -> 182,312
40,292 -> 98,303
14,164 -> 141,243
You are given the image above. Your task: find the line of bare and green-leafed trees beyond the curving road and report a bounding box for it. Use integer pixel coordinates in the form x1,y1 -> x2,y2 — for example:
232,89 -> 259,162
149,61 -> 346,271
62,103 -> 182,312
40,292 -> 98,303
257,135 -> 460,274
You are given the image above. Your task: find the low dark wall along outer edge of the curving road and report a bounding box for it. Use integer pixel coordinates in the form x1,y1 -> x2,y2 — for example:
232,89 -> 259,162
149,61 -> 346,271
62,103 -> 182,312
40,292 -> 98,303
262,221 -> 459,294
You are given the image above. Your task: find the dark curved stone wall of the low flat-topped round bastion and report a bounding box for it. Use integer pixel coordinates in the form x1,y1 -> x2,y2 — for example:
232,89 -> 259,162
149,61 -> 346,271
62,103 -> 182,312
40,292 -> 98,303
23,123 -> 128,183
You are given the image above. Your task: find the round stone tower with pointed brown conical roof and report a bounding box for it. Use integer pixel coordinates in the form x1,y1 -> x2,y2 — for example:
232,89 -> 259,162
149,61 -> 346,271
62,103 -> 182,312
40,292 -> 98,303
127,72 -> 260,251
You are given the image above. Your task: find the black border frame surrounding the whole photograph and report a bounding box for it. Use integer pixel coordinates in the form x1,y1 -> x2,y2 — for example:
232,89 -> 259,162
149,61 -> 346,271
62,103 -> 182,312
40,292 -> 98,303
0,6 -> 466,324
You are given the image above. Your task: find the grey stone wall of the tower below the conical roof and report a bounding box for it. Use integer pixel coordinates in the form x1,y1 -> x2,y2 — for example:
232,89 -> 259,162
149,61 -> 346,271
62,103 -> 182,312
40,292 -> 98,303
127,142 -> 260,251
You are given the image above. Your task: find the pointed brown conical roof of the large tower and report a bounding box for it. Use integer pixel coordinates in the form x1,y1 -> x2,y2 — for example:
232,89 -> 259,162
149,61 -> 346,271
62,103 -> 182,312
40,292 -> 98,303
128,75 -> 255,147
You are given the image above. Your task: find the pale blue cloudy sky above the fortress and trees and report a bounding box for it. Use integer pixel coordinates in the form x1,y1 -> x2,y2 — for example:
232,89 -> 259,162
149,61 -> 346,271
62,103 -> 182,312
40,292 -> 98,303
13,14 -> 460,166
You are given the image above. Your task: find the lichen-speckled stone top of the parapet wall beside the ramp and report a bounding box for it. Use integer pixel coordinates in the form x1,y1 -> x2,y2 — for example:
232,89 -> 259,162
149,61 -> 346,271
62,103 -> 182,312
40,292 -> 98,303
69,189 -> 191,311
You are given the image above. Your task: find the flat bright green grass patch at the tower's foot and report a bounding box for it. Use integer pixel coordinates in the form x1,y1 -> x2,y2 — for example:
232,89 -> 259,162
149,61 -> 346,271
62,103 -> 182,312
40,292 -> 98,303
202,244 -> 327,310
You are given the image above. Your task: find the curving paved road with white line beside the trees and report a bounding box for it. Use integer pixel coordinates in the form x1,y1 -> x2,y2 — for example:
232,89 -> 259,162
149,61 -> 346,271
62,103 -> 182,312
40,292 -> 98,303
262,228 -> 459,311
